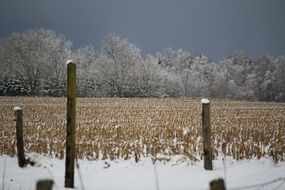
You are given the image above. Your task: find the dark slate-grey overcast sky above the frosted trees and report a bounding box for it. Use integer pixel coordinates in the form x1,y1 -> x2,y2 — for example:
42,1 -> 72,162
0,0 -> 285,60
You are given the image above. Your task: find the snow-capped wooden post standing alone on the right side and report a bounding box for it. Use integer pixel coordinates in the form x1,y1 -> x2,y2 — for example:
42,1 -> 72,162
201,98 -> 213,170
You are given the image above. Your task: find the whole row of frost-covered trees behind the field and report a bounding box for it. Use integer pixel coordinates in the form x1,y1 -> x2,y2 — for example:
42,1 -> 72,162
0,29 -> 285,101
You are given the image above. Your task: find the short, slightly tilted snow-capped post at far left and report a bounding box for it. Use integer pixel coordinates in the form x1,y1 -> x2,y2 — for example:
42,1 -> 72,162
14,106 -> 26,168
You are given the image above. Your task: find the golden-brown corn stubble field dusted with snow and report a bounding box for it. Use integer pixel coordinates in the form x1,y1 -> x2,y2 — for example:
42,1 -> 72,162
0,97 -> 285,161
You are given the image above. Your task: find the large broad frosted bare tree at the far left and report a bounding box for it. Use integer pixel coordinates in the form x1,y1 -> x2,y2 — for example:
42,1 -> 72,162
0,29 -> 71,95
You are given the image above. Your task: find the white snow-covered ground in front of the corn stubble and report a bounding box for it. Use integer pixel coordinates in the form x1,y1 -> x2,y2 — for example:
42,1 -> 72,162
0,155 -> 285,190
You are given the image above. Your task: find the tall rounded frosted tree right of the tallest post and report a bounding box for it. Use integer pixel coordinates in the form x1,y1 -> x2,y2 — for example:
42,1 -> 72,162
96,34 -> 141,97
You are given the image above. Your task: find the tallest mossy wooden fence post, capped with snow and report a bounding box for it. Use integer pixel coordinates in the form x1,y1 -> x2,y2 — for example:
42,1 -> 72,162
64,60 -> 76,188
